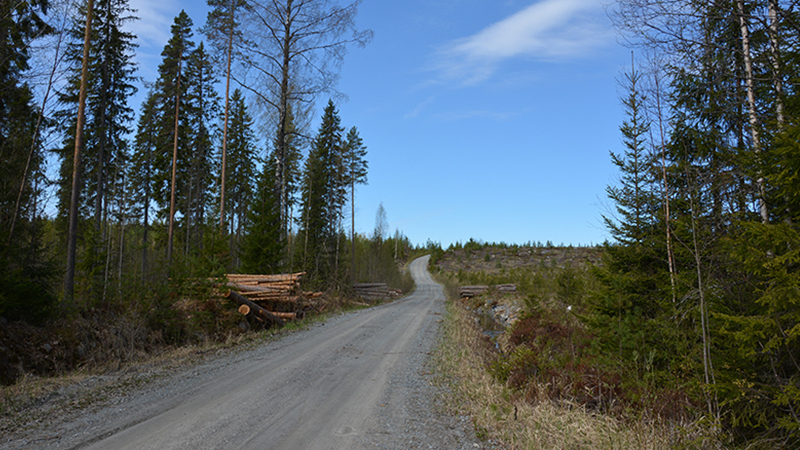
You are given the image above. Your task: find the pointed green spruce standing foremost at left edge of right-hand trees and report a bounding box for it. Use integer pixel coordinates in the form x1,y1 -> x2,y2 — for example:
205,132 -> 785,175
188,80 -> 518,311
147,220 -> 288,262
587,59 -> 669,375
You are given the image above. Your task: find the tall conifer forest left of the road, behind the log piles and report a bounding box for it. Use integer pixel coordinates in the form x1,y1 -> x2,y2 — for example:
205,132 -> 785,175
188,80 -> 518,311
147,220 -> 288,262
0,0 -> 418,352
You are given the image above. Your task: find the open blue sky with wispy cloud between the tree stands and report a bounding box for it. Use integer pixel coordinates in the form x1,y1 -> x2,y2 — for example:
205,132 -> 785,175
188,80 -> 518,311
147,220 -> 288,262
131,0 -> 630,246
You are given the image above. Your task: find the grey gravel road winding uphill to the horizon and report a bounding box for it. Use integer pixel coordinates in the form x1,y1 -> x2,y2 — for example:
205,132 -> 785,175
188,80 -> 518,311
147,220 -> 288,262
6,257 -> 489,450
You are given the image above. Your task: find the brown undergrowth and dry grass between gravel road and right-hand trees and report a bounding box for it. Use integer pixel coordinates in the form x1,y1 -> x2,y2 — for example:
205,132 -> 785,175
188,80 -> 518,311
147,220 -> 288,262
432,247 -> 718,449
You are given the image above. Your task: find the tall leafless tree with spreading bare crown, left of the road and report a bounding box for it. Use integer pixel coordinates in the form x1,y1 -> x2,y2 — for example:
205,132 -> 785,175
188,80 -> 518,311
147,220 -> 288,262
234,0 -> 372,243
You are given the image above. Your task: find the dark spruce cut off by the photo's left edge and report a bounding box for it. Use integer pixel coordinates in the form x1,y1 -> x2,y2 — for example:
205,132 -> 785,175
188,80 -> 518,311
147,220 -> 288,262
0,0 -> 56,320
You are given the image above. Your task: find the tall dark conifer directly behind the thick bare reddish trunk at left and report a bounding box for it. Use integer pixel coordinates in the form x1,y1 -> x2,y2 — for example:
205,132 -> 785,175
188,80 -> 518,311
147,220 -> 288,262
56,0 -> 136,298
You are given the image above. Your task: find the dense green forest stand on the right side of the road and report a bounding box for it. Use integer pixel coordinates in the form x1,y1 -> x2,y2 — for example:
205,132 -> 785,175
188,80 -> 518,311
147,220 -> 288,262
583,0 -> 800,448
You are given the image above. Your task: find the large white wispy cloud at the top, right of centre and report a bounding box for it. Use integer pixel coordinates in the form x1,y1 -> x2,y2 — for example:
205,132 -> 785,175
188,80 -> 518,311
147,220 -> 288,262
435,0 -> 613,85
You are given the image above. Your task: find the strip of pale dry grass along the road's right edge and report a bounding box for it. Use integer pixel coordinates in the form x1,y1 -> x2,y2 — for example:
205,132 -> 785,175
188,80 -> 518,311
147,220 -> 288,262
436,303 -> 699,450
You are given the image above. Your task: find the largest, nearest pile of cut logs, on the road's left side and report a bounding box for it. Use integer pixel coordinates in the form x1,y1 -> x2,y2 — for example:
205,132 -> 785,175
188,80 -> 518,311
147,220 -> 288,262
225,272 -> 322,325
